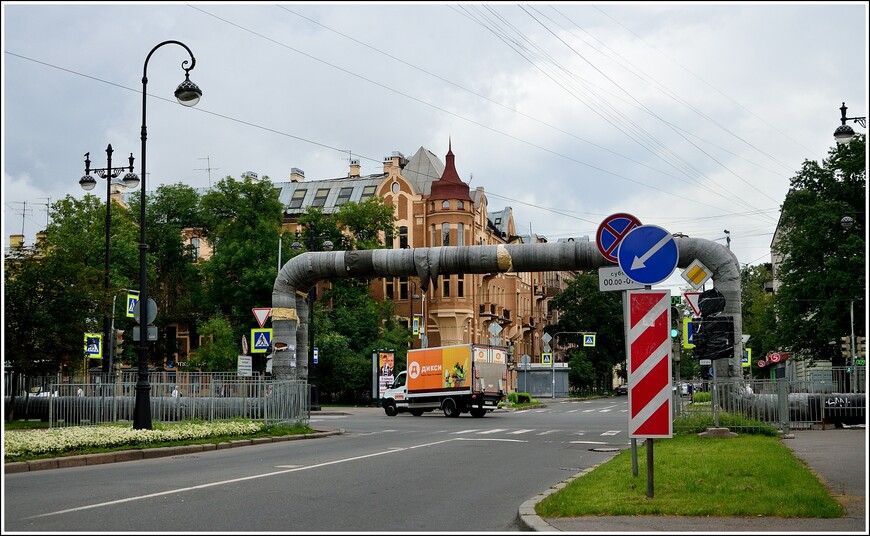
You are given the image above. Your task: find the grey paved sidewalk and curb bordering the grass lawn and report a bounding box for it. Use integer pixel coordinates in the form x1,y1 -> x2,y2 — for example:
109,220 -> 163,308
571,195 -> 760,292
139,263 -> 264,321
518,427 -> 868,534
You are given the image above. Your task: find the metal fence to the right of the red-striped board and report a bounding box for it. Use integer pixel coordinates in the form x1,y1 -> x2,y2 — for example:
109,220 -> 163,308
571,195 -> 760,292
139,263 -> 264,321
674,367 -> 867,433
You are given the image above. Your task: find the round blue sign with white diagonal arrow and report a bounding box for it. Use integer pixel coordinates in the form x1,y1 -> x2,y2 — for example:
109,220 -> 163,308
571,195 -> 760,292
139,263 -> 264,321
617,225 -> 680,285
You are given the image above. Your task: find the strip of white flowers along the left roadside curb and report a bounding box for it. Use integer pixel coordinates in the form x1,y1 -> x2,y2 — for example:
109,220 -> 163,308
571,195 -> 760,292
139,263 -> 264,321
3,421 -> 264,459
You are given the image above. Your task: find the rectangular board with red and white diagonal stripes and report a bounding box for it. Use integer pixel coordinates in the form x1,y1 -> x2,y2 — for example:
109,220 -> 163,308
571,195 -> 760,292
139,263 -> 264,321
626,290 -> 673,438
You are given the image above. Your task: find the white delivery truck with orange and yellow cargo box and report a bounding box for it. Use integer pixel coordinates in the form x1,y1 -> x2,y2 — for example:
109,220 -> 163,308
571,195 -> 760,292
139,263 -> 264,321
383,344 -> 507,417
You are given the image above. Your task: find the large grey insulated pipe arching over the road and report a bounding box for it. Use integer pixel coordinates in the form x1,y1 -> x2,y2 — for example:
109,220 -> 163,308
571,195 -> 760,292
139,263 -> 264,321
272,237 -> 743,381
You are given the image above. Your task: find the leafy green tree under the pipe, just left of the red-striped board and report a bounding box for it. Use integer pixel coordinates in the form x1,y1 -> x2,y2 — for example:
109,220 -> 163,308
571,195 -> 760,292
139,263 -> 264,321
547,272 -> 626,391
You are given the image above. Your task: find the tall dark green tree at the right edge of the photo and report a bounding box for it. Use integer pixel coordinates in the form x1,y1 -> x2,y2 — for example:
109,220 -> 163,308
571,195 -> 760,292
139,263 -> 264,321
774,135 -> 867,365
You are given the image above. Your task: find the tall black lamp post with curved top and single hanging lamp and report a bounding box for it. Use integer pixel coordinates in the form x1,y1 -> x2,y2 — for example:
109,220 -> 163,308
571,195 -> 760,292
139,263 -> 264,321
133,40 -> 202,430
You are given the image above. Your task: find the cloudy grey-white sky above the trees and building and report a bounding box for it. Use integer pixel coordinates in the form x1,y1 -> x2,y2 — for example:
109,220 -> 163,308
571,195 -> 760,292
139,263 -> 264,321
2,2 -> 868,294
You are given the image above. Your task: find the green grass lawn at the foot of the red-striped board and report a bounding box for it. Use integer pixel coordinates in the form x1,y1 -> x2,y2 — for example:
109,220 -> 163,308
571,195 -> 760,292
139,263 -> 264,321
535,434 -> 845,518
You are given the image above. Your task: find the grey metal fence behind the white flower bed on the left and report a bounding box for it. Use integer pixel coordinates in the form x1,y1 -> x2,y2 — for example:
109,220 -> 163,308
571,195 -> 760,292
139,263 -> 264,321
5,373 -> 310,427
